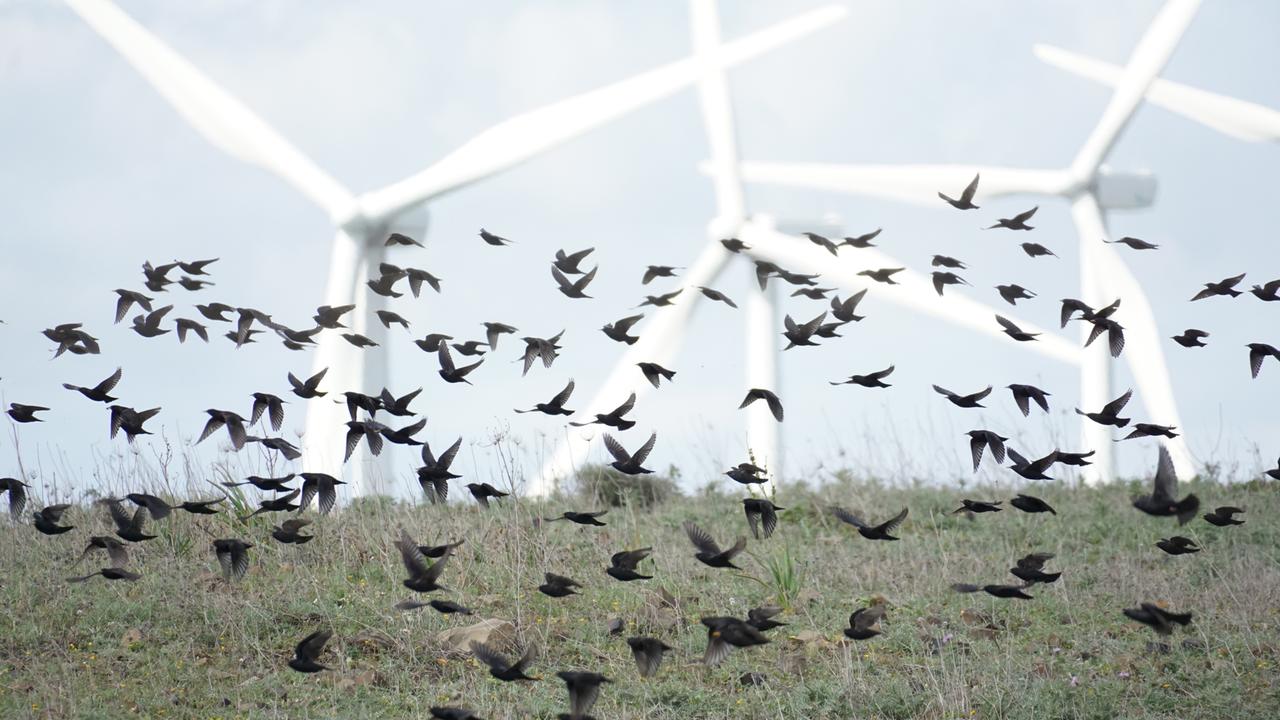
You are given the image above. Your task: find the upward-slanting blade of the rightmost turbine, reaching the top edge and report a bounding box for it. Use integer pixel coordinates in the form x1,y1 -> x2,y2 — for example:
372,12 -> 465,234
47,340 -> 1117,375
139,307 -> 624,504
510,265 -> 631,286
1071,0 -> 1199,182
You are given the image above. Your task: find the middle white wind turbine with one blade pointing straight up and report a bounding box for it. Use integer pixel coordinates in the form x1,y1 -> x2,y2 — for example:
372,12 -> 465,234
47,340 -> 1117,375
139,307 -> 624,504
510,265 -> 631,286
529,0 -> 1082,495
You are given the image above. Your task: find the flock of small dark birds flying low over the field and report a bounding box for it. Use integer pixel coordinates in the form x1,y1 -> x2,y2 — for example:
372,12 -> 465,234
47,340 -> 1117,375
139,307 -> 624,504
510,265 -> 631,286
0,177 -> 1280,720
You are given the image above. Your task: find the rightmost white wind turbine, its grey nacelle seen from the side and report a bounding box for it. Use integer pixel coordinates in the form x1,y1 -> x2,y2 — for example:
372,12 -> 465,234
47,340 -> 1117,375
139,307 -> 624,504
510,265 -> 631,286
741,0 -> 1199,482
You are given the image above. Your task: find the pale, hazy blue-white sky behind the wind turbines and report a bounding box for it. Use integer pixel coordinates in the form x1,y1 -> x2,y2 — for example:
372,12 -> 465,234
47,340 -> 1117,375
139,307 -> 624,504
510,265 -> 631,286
0,0 -> 1280,495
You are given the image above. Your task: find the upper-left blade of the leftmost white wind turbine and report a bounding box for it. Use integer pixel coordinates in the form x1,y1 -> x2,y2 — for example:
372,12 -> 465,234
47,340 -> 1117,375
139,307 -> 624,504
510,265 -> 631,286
67,0 -> 352,218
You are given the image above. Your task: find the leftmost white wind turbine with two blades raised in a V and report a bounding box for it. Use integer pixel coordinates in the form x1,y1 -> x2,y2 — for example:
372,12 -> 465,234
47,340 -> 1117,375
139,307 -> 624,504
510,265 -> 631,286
67,0 -> 845,495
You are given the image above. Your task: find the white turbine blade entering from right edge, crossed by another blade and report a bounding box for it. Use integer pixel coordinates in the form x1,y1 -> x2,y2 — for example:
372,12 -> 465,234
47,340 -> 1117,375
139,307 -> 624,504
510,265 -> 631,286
1033,45 -> 1280,142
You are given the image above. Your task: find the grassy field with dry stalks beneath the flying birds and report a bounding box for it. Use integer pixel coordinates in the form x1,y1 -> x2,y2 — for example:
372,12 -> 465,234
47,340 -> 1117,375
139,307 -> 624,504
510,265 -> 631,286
0,471 -> 1280,720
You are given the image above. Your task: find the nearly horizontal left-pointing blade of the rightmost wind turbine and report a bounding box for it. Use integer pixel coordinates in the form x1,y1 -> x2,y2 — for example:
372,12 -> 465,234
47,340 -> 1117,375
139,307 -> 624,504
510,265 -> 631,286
740,161 -> 1071,208
